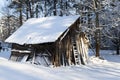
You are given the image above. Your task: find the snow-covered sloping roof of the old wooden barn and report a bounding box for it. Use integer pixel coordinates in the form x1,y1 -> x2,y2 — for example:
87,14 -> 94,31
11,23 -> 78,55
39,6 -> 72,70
5,15 -> 79,45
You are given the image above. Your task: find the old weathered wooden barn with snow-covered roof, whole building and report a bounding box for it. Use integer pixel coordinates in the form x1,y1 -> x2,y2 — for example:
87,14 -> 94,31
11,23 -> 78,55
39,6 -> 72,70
5,15 -> 89,66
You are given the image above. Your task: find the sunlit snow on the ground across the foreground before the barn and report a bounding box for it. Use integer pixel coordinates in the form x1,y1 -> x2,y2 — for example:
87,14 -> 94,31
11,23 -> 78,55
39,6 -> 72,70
0,51 -> 120,80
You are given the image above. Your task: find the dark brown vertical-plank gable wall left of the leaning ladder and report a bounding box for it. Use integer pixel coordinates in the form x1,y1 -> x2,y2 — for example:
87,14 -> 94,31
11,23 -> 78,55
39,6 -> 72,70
53,19 -> 79,66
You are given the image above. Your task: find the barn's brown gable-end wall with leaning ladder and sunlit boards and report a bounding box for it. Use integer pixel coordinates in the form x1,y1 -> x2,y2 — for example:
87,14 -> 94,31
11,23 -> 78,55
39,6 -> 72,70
53,19 -> 89,66
